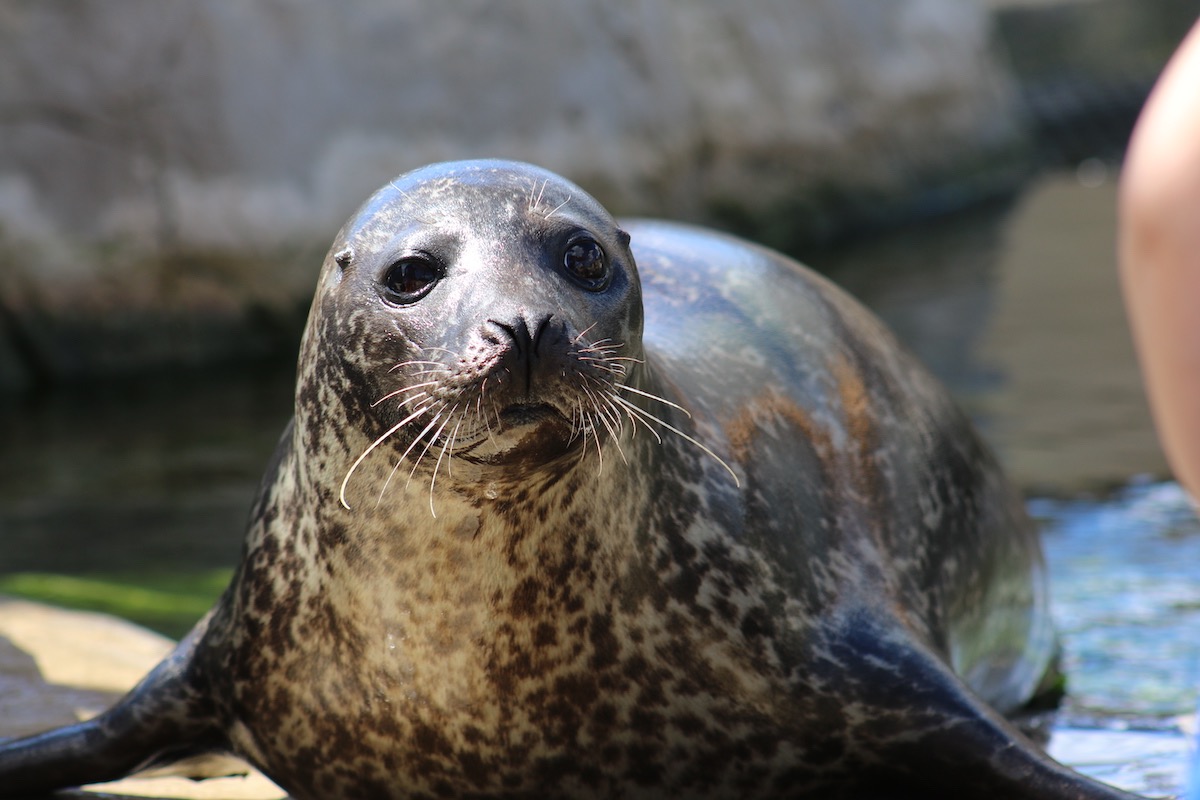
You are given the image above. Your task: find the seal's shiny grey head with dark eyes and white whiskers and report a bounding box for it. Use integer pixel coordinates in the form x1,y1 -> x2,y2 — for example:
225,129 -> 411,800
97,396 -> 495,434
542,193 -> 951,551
298,162 -> 642,501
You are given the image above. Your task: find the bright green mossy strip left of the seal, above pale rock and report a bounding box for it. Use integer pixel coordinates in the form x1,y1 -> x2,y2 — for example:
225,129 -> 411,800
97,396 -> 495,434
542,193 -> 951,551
0,570 -> 232,638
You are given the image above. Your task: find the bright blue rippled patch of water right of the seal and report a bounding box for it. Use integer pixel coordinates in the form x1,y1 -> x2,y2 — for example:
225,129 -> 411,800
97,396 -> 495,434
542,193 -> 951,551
1030,482 -> 1200,794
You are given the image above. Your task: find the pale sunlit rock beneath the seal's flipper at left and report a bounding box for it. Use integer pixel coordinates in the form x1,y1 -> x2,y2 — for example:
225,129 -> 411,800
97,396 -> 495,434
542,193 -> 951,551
0,597 -> 284,800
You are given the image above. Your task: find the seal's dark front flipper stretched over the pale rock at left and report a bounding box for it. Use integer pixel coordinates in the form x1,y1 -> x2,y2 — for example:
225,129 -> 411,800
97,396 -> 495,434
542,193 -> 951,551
0,622 -> 228,798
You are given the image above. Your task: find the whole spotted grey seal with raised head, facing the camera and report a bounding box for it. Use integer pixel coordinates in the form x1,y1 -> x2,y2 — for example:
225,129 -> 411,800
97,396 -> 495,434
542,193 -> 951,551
0,161 -> 1142,799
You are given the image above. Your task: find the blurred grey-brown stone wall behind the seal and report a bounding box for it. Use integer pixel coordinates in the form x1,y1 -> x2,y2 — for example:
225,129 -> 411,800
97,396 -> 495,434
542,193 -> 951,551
0,0 -> 1020,385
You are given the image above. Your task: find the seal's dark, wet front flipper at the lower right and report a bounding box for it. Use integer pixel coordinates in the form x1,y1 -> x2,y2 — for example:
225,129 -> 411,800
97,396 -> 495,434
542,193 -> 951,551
815,610 -> 1140,800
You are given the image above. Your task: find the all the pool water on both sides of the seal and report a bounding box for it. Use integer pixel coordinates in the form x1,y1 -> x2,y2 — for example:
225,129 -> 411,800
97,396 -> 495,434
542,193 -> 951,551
0,169 -> 1200,794
